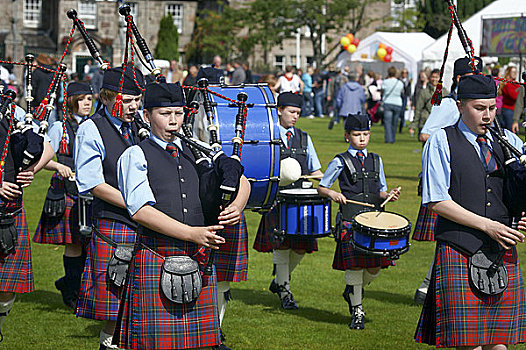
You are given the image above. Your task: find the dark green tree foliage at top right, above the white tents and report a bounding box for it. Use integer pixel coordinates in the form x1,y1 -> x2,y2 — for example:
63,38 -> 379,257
420,0 -> 500,39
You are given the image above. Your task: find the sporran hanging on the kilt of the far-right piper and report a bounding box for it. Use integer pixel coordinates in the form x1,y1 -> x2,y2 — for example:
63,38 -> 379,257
468,249 -> 508,296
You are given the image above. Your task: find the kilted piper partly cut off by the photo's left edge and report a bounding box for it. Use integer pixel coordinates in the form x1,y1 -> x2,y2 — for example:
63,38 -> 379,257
0,100 -> 53,342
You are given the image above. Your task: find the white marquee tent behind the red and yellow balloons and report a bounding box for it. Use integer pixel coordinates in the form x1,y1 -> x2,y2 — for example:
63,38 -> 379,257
337,32 -> 434,81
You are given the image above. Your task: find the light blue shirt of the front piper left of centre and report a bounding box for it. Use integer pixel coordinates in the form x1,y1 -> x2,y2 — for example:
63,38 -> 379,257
117,133 -> 186,216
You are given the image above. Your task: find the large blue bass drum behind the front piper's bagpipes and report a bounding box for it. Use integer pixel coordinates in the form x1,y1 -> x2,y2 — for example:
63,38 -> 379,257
209,84 -> 280,209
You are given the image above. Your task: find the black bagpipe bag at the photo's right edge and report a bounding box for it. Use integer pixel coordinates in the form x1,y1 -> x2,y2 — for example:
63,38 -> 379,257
504,162 -> 526,216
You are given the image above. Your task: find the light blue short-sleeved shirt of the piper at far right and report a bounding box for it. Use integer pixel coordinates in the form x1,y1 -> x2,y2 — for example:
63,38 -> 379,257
422,120 -> 522,204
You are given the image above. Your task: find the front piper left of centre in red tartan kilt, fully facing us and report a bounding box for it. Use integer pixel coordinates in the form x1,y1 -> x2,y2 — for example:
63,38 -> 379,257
114,83 -> 249,349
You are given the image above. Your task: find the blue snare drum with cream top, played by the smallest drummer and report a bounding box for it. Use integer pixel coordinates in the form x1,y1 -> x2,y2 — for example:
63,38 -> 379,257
351,211 -> 411,259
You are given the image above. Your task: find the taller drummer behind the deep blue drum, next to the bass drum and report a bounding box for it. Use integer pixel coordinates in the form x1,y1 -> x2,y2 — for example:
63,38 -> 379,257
254,92 -> 323,310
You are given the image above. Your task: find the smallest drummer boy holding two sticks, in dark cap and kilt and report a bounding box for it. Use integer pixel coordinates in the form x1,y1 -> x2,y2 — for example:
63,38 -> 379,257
318,114 -> 400,329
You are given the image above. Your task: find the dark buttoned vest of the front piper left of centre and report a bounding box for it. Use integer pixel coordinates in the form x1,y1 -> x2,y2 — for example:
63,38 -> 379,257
139,139 -> 204,255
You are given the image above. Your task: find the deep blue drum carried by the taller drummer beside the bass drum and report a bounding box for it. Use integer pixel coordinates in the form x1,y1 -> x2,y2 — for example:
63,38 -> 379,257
278,188 -> 331,238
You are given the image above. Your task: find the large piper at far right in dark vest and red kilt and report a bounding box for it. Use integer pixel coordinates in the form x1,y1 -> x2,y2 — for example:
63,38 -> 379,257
415,75 -> 526,350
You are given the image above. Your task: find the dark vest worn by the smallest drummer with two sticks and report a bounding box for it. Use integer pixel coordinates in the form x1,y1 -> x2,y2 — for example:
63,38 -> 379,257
336,152 -> 382,216
